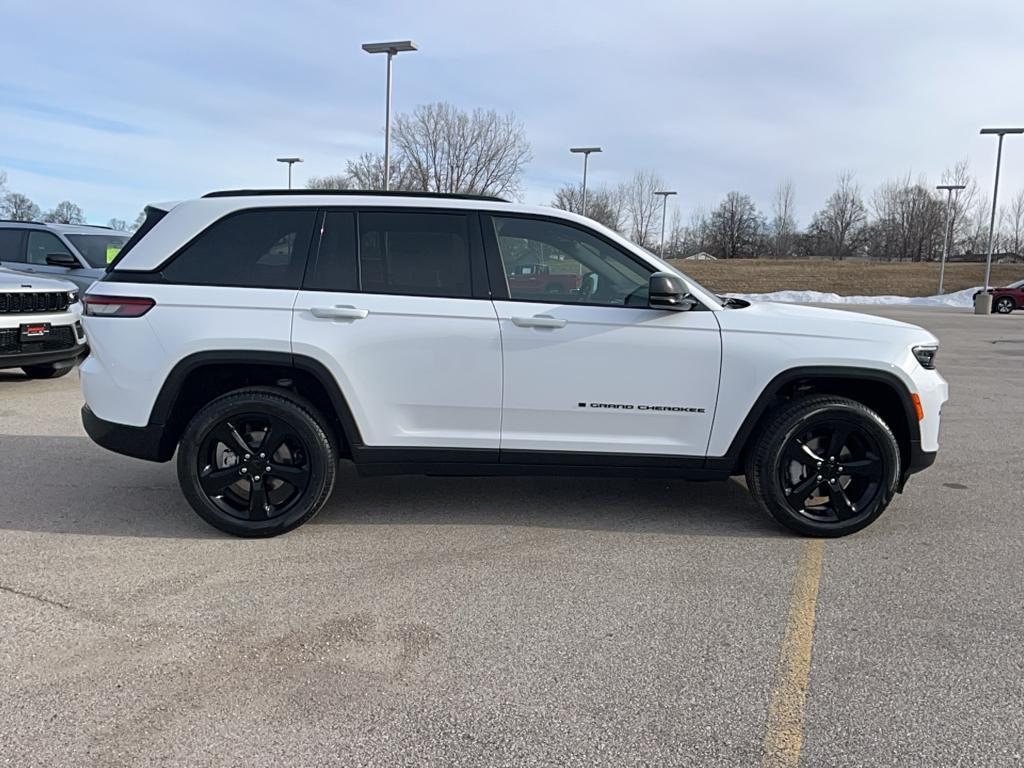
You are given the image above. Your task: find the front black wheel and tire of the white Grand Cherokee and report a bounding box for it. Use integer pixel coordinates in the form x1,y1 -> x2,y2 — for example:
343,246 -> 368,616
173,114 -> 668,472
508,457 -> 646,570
746,395 -> 900,538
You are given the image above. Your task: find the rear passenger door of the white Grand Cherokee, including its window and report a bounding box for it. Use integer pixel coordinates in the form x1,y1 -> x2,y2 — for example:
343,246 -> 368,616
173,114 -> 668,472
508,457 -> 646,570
292,207 -> 502,454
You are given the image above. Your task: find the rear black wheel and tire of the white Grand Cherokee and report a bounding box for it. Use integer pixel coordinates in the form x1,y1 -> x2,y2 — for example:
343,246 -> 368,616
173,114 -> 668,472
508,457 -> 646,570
177,388 -> 338,538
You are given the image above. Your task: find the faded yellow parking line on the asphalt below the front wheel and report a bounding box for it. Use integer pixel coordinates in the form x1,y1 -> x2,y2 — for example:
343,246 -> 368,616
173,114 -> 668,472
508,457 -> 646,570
763,539 -> 824,768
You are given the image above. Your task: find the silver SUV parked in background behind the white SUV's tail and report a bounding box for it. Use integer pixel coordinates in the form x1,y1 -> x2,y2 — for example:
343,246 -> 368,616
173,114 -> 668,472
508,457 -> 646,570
0,221 -> 129,291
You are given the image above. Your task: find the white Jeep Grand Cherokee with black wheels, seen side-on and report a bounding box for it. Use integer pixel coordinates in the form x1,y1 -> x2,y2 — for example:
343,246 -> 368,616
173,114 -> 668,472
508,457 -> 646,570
81,190 -> 947,537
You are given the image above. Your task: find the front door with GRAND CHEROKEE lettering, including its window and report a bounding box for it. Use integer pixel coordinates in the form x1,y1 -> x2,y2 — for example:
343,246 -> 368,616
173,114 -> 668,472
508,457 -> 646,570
483,215 -> 721,463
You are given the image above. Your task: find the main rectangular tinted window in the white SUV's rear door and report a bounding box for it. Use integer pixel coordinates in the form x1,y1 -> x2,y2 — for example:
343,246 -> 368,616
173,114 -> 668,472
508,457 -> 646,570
359,212 -> 471,298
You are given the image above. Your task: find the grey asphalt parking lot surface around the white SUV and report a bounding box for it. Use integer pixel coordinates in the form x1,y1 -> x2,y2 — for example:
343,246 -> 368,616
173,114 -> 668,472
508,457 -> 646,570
0,308 -> 1024,766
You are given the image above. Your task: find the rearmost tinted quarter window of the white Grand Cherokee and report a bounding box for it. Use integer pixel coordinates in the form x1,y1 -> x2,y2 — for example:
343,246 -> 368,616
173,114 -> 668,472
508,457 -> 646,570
163,209 -> 315,289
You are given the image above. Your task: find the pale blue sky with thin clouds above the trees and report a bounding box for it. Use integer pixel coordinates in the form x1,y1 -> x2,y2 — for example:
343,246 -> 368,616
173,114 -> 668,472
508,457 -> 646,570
0,0 -> 1024,223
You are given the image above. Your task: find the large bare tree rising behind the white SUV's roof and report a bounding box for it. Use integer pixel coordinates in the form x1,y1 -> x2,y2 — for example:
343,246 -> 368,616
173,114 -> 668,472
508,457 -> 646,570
391,102 -> 532,198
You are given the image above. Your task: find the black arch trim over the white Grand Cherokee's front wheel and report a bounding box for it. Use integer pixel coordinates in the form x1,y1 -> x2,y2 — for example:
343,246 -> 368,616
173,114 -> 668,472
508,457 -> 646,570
706,366 -> 928,474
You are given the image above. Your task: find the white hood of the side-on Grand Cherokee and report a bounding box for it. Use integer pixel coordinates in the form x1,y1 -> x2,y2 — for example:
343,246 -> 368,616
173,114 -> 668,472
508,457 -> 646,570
718,301 -> 936,344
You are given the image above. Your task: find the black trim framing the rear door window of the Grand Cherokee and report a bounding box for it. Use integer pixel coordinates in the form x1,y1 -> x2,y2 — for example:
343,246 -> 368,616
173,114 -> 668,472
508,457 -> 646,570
301,206 -> 492,301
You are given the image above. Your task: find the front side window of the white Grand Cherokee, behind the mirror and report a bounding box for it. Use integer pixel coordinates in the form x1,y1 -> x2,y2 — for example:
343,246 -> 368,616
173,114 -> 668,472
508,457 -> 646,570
493,216 -> 650,307
